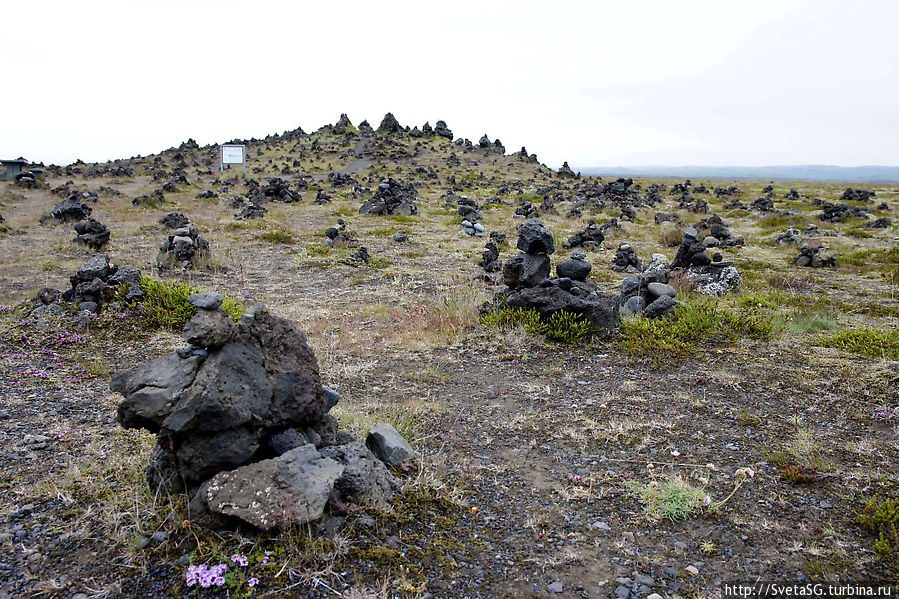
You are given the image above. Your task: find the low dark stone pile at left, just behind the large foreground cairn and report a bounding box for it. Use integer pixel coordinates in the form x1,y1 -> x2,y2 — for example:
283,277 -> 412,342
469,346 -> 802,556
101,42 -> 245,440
30,254 -> 144,320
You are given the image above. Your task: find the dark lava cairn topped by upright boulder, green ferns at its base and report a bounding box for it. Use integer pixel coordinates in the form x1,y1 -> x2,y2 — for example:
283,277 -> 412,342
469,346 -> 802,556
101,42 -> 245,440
500,219 -> 618,336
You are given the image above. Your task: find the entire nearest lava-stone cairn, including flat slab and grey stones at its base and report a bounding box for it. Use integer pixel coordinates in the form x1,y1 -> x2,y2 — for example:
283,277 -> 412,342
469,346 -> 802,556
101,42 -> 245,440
110,293 -> 414,530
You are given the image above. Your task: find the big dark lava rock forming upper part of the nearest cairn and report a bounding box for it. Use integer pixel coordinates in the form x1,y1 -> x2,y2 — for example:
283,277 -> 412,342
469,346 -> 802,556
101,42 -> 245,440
110,304 -> 326,488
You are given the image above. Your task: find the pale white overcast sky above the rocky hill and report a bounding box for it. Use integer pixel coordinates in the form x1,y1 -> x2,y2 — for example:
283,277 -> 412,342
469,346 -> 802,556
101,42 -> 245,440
0,0 -> 899,168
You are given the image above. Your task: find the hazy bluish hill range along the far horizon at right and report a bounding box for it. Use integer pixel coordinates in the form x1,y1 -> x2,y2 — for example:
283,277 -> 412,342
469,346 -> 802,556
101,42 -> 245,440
574,164 -> 899,183
